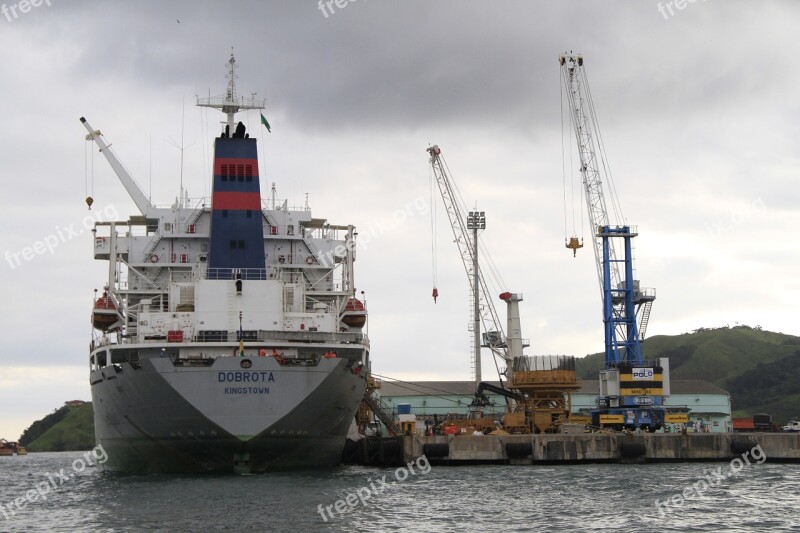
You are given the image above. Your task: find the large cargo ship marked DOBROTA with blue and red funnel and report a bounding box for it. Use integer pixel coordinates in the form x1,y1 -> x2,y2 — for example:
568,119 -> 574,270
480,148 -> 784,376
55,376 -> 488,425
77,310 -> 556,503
81,54 -> 369,474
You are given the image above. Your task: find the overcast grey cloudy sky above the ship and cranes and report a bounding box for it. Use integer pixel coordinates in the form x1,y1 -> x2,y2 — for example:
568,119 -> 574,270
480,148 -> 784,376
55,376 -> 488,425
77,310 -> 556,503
0,0 -> 800,439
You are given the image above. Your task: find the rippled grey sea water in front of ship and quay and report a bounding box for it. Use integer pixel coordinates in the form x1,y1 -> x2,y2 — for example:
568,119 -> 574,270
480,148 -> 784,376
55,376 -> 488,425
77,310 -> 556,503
0,452 -> 800,532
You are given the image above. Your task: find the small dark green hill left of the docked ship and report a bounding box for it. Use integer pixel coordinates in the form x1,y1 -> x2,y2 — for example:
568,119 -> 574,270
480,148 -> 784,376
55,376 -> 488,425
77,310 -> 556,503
20,403 -> 95,452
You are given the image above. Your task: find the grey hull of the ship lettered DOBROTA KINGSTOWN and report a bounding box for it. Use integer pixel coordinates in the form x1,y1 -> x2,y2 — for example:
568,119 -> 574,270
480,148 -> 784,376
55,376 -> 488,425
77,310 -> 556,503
91,357 -> 366,474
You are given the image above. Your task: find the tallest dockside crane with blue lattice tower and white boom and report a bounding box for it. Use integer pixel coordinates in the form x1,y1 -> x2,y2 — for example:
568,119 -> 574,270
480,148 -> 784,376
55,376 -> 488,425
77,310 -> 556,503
559,52 -> 669,430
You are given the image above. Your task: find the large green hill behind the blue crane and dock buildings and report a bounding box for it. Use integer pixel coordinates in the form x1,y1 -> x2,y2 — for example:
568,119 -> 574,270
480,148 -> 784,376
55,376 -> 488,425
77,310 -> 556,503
576,326 -> 800,422
